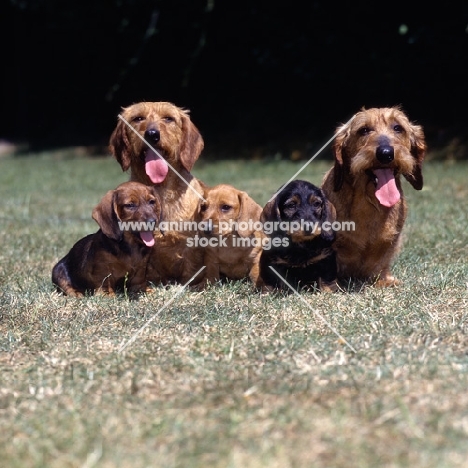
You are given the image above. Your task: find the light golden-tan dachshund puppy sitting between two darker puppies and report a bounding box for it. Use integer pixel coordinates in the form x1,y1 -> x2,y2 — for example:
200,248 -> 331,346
199,184 -> 265,284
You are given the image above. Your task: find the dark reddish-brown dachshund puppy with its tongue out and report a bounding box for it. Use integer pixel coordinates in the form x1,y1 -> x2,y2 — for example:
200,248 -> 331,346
52,182 -> 161,297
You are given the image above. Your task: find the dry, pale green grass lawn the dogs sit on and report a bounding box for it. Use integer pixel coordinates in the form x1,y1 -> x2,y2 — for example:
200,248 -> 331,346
0,154 -> 468,468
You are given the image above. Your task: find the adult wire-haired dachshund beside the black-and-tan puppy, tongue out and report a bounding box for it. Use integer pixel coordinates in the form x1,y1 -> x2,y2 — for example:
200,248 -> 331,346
322,107 -> 426,286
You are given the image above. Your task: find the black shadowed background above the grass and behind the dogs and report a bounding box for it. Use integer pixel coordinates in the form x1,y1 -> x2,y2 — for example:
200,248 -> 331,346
0,0 -> 468,157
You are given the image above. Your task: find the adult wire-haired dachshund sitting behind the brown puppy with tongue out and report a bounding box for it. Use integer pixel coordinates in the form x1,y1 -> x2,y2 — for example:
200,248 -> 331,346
110,102 -> 204,284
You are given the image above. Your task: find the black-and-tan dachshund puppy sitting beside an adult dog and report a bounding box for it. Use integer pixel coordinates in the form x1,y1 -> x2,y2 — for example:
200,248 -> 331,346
257,180 -> 337,291
